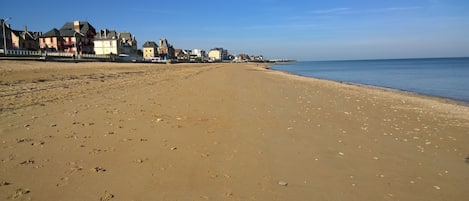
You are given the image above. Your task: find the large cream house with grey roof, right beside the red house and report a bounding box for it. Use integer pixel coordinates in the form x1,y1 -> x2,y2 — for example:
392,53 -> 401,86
93,29 -> 137,55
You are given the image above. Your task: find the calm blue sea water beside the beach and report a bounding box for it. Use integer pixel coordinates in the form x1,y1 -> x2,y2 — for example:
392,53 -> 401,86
272,58 -> 469,103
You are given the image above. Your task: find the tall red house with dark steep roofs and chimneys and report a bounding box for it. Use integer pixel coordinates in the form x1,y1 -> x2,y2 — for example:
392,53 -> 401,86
39,21 -> 96,54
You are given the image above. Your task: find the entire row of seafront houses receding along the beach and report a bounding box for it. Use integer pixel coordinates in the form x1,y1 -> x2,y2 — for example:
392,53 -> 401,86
0,19 -> 262,62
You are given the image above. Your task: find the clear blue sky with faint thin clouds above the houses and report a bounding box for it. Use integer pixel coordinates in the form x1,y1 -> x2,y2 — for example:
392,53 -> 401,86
0,0 -> 469,60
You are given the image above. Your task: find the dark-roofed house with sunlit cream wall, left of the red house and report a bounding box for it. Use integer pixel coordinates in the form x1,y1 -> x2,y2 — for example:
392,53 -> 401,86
11,26 -> 42,51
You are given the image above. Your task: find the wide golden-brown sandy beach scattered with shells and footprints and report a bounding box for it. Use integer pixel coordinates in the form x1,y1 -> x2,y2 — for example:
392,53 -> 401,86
0,61 -> 469,201
